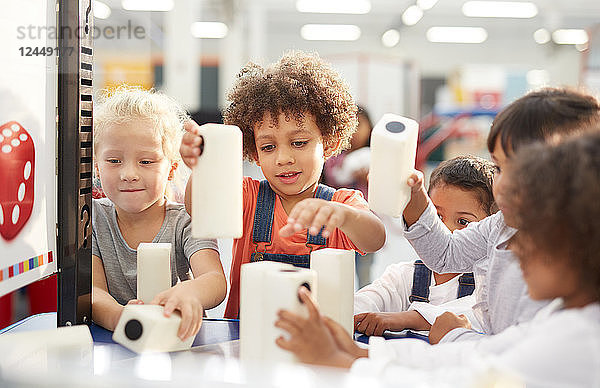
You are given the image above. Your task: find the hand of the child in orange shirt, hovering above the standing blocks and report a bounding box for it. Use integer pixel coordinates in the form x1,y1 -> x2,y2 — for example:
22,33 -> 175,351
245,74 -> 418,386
279,198 -> 352,238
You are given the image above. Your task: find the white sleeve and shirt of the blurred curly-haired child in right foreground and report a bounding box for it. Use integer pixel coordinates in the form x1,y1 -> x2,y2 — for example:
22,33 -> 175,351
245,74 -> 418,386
352,299 -> 600,387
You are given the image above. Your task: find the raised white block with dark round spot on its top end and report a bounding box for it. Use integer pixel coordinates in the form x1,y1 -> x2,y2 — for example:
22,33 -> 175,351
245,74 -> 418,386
369,113 -> 419,217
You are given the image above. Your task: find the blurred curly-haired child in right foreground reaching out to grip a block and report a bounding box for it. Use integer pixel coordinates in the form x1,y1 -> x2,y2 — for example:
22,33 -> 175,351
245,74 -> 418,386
275,131 -> 600,387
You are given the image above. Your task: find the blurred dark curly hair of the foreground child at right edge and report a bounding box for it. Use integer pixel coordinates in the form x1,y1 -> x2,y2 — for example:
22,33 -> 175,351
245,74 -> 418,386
507,127 -> 600,300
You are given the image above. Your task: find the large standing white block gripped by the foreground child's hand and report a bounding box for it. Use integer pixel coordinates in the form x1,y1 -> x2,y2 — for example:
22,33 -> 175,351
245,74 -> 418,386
240,261 -> 316,362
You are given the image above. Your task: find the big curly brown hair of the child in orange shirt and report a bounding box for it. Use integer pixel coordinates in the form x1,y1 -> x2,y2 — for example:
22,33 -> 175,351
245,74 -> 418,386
223,51 -> 358,160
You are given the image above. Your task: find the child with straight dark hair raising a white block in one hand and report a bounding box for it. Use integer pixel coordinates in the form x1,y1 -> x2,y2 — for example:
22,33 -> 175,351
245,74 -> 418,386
404,88 -> 600,343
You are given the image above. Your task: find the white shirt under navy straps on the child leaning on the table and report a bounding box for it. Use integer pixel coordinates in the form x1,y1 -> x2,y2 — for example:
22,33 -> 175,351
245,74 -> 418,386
354,262 -> 480,329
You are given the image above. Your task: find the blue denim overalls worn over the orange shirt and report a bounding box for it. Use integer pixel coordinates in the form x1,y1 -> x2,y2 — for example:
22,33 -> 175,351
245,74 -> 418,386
250,180 -> 335,268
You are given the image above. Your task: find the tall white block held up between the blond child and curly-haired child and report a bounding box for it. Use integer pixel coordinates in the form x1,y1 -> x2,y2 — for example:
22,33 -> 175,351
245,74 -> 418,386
192,124 -> 243,238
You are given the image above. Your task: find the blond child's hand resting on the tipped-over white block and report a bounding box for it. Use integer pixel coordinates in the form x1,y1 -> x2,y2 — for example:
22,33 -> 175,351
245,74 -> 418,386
151,280 -> 204,341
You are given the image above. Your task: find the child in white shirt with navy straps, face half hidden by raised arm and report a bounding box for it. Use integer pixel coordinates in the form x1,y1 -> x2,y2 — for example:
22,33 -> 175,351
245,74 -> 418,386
354,157 -> 497,335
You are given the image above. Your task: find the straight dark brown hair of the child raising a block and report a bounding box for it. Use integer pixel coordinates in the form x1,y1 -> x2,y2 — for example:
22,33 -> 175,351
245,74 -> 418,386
487,88 -> 600,155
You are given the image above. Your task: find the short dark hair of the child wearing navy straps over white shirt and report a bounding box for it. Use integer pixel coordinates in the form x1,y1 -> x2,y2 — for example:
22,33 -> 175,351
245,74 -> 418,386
429,156 -> 498,215
